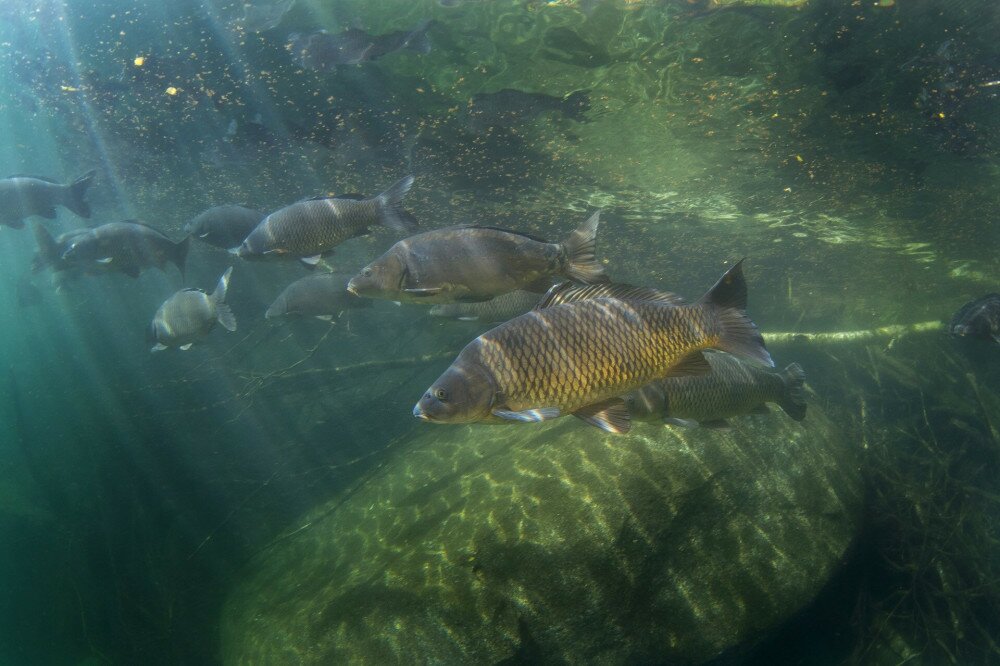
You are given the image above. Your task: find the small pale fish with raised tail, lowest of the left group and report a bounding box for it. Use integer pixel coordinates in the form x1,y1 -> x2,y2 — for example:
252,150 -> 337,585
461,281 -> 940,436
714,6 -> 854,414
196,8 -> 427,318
149,266 -> 236,351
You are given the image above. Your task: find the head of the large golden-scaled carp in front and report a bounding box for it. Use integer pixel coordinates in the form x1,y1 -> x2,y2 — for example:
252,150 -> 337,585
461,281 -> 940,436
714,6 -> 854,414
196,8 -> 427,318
413,358 -> 496,423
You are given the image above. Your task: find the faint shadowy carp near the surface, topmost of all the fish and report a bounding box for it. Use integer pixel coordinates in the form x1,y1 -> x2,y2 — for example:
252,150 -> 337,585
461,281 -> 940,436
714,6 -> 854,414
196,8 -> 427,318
288,20 -> 433,73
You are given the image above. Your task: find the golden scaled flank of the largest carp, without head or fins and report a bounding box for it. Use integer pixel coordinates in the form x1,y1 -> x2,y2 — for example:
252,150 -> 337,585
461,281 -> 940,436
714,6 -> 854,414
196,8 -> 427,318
477,299 -> 717,413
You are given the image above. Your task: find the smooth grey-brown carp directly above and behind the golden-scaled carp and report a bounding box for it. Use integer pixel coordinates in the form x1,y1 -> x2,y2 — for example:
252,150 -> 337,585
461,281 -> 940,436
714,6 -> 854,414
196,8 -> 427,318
347,211 -> 607,303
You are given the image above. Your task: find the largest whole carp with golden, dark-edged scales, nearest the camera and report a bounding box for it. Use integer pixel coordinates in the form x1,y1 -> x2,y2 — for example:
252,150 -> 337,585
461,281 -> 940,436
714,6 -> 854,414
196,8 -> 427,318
413,261 -> 774,433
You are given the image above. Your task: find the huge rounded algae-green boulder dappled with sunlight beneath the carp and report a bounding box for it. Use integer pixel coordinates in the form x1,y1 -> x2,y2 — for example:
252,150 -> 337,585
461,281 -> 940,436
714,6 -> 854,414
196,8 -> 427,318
222,405 -> 862,664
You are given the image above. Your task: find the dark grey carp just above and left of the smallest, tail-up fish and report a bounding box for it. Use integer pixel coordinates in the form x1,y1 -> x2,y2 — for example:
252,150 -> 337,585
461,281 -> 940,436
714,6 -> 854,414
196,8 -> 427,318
62,220 -> 190,278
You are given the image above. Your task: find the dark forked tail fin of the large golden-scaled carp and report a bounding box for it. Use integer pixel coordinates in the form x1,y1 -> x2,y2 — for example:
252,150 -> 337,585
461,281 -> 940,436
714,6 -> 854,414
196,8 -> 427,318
698,259 -> 774,368
